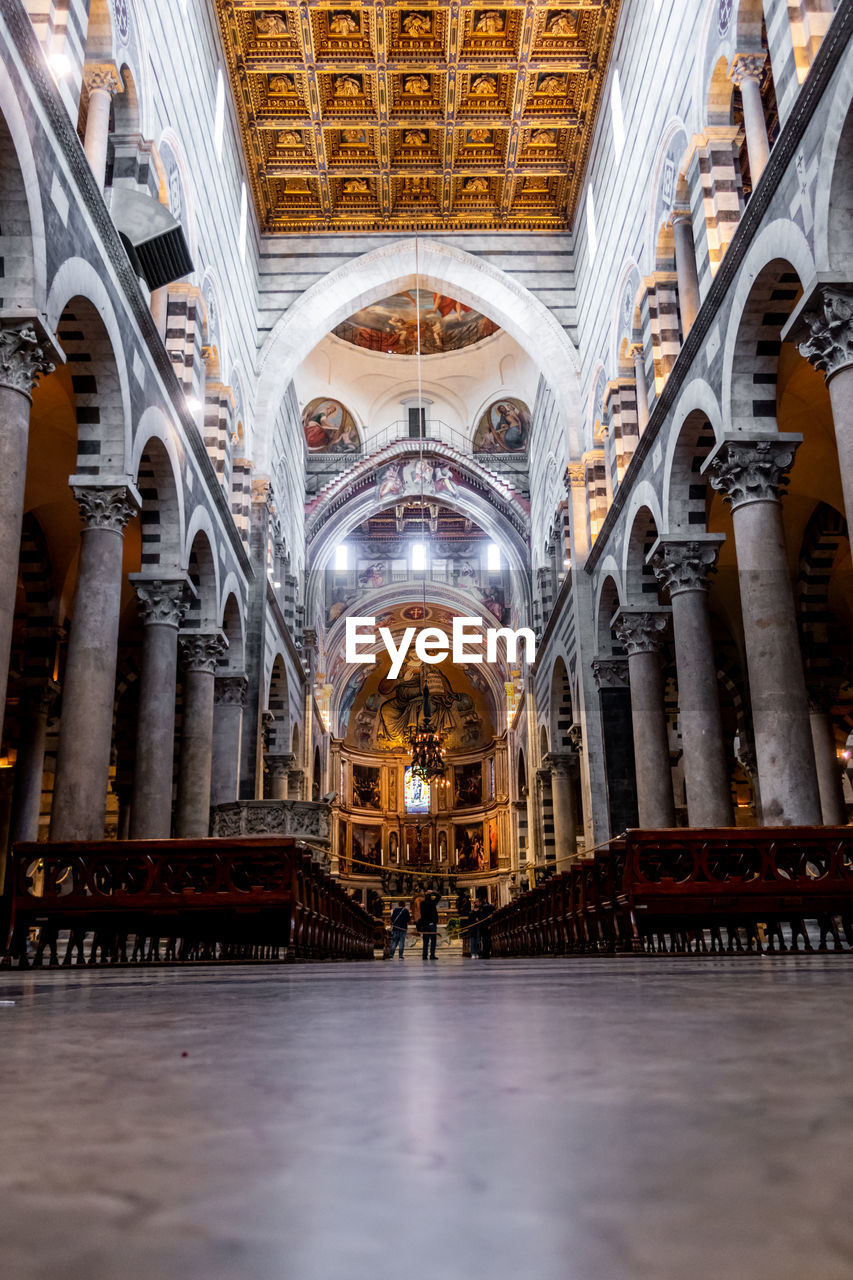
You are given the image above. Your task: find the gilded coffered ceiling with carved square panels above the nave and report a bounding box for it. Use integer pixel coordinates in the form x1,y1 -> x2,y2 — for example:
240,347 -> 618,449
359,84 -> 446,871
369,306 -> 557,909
215,0 -> 619,232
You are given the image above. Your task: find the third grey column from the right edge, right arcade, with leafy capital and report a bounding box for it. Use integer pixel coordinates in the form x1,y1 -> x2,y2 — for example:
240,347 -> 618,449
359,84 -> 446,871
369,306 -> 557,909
651,534 -> 734,827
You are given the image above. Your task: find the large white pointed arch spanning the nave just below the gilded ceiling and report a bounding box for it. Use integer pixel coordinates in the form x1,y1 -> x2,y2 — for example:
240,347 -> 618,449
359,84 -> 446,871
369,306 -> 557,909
256,238 -> 580,471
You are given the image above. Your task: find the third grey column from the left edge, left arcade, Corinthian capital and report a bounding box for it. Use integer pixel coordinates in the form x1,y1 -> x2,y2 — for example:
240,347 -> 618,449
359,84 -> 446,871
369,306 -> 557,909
131,579 -> 186,840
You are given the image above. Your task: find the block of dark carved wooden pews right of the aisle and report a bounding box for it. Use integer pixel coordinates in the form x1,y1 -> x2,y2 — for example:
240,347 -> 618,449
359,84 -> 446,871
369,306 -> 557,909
489,827 -> 853,956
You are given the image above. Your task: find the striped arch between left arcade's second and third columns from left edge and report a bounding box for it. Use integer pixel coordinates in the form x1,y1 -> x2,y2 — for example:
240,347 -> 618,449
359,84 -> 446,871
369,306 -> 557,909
133,407 -> 184,571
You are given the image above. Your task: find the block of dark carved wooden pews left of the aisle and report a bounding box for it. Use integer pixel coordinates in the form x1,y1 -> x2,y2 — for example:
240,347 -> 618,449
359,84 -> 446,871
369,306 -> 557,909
3,837 -> 375,968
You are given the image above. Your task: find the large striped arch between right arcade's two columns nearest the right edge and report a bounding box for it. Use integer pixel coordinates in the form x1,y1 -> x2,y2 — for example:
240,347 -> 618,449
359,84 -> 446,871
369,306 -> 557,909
722,221 -> 813,434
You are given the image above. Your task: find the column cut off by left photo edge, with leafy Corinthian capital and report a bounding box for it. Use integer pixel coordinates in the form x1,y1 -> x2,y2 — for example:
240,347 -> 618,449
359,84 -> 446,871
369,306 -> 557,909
0,321 -> 54,747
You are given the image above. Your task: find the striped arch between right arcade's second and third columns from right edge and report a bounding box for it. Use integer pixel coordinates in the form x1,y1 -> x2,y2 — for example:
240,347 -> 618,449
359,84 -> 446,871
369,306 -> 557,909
662,380 -> 721,532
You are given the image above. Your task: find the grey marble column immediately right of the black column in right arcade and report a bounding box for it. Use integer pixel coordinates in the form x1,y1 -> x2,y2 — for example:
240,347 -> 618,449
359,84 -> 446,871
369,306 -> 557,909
616,609 -> 675,827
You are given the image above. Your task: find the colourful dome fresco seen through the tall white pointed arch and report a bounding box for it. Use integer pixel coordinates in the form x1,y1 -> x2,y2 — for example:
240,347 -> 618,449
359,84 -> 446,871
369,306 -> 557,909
334,289 -> 500,356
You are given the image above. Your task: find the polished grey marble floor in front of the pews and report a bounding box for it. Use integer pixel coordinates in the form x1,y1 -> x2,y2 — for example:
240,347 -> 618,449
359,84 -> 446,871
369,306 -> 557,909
0,954 -> 853,1280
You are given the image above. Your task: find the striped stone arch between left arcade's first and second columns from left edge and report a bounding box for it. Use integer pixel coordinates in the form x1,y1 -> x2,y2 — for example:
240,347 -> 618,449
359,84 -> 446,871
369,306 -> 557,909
47,257 -> 132,483
